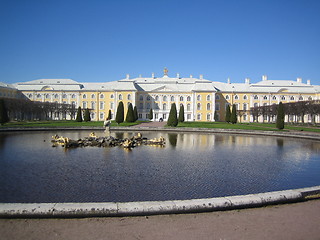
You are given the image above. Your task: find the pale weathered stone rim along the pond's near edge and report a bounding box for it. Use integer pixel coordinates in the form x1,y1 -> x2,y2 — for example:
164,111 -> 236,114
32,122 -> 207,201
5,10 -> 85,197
0,186 -> 320,218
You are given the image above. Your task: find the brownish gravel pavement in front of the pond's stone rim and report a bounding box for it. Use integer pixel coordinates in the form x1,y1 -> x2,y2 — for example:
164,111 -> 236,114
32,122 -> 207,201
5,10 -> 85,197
0,199 -> 320,240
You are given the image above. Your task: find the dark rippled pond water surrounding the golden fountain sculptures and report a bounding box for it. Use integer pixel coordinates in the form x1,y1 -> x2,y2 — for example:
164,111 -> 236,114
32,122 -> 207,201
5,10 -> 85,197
0,131 -> 320,203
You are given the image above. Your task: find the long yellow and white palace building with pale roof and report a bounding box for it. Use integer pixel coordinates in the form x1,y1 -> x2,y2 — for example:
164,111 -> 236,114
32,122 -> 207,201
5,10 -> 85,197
0,69 -> 320,122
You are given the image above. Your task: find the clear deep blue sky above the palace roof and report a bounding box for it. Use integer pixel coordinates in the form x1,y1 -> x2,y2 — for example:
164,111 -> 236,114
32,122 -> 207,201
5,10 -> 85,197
0,0 -> 320,85
